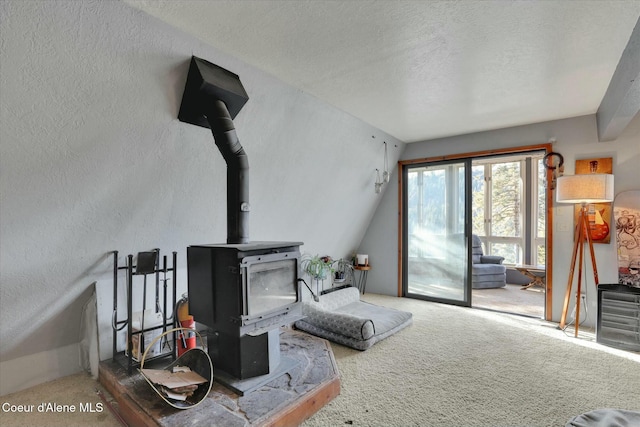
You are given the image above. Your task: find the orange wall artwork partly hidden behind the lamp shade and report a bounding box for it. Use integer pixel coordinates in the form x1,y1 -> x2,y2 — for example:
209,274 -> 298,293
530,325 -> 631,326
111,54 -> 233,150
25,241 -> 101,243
574,157 -> 613,243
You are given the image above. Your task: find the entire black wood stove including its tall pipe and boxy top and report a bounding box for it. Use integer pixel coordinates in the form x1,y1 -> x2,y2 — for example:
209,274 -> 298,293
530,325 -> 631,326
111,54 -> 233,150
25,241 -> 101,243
178,57 -> 302,394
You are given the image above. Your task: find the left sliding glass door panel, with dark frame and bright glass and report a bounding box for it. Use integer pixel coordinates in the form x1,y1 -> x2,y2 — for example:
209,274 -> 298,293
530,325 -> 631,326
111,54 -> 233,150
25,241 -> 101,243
402,160 -> 471,306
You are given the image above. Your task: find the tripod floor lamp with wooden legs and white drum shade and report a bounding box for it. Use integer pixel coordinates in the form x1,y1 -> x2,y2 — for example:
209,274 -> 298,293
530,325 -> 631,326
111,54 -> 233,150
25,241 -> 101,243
556,173 -> 613,338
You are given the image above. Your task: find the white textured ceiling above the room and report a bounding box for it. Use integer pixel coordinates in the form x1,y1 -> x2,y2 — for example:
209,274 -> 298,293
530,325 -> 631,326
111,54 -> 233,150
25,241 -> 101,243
124,0 -> 640,142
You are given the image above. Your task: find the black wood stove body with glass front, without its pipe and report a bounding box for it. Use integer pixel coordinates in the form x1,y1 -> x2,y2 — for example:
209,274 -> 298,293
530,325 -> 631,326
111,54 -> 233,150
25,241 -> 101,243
187,242 -> 302,379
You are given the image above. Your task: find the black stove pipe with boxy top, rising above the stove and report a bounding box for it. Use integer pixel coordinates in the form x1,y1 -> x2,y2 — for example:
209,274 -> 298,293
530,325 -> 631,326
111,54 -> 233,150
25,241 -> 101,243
178,56 -> 250,244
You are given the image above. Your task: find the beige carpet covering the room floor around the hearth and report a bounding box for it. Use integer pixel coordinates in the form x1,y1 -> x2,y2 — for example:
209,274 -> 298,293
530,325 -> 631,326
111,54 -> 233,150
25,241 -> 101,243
0,290 -> 640,427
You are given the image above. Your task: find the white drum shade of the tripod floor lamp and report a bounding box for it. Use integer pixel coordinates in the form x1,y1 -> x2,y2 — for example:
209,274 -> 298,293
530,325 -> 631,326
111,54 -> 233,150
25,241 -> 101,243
556,173 -> 614,203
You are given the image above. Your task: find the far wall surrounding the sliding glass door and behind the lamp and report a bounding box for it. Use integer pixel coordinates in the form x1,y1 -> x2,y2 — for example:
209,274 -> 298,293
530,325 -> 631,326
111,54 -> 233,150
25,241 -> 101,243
359,115 -> 640,326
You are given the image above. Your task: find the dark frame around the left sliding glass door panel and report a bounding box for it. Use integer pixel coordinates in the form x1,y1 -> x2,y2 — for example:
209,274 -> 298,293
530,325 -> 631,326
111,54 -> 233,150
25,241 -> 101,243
399,158 -> 472,307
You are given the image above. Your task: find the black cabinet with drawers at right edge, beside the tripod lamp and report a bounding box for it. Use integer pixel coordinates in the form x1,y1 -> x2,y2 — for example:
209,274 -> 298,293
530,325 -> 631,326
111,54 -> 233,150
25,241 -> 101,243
596,284 -> 640,351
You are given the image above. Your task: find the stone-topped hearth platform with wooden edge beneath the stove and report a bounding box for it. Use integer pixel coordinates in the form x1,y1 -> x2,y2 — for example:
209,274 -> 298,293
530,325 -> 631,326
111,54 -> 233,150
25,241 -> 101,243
99,329 -> 340,427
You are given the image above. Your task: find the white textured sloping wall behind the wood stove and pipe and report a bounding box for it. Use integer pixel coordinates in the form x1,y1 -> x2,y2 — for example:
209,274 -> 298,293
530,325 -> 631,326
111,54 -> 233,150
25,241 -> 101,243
0,1 -> 404,394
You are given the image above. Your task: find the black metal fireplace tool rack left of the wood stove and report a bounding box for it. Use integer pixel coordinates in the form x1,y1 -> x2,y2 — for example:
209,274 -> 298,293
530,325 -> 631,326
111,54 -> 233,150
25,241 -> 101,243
111,248 -> 178,375
